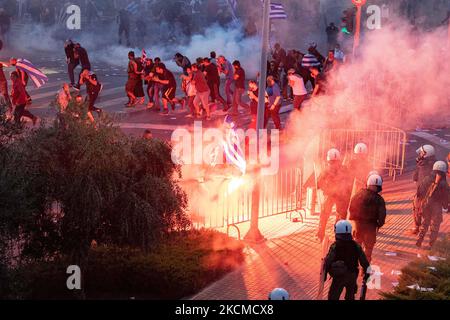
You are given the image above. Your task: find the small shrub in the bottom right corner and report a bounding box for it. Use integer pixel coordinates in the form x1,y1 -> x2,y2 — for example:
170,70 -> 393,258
381,236 -> 450,300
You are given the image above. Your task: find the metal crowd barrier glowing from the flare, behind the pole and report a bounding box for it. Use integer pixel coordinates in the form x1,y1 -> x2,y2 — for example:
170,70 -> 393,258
181,168 -> 303,237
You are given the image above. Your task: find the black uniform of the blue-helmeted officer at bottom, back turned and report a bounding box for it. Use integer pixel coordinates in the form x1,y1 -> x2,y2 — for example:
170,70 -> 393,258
325,235 -> 369,300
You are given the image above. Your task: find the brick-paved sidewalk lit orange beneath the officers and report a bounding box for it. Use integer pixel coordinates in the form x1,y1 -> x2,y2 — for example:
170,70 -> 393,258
193,174 -> 450,300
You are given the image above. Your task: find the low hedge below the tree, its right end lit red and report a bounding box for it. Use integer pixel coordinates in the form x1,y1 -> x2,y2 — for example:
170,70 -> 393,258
0,231 -> 244,299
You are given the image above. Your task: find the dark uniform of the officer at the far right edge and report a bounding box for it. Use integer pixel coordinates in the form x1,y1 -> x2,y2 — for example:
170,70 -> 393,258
417,171 -> 449,247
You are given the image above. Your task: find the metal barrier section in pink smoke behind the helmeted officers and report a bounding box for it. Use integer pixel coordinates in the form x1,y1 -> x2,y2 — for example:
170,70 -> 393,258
319,122 -> 406,178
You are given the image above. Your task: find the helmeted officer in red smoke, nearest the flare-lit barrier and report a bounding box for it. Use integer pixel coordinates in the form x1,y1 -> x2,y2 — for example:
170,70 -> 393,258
317,149 -> 349,241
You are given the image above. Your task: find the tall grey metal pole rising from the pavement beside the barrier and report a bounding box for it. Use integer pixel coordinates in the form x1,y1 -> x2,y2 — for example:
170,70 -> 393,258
244,0 -> 270,242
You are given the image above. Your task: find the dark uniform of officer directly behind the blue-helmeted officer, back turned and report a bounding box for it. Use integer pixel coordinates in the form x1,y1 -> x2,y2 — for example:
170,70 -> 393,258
349,189 -> 386,261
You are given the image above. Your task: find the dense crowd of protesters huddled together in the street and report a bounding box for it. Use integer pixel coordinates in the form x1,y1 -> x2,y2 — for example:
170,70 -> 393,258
115,43 -> 345,129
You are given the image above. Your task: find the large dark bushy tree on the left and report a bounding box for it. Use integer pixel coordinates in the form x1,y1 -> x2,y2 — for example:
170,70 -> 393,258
0,114 -> 189,262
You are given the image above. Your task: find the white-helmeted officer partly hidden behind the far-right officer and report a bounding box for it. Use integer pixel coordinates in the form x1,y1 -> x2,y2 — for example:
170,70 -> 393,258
411,144 -> 436,234
